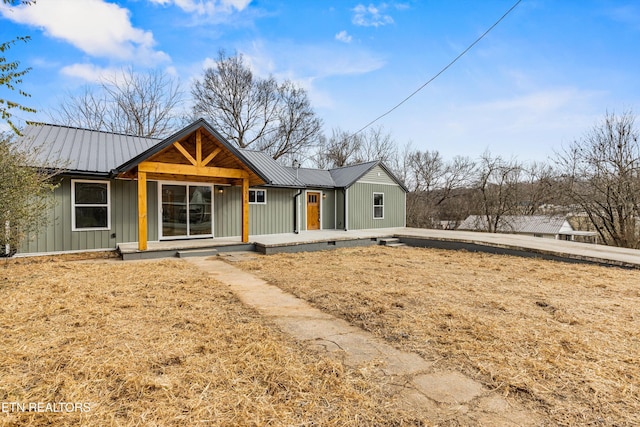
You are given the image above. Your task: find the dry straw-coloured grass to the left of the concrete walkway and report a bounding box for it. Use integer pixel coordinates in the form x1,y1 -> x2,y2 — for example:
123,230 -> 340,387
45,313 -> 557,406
0,257 -> 418,426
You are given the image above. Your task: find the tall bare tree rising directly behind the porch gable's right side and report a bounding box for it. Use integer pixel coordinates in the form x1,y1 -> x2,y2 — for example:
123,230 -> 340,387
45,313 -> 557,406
191,50 -> 322,159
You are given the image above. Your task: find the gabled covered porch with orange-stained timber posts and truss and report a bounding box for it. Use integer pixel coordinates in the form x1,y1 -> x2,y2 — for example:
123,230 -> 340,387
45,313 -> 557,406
116,120 -> 265,251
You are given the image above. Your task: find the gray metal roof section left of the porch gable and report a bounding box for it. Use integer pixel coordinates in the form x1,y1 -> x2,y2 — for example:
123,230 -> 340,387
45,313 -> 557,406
18,124 -> 160,175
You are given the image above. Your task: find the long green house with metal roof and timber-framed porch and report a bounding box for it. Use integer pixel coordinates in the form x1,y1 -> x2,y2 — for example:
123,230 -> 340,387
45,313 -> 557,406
18,119 -> 407,253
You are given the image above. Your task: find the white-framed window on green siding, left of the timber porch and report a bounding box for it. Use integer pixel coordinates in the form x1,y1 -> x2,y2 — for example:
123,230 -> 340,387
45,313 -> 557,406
71,180 -> 111,231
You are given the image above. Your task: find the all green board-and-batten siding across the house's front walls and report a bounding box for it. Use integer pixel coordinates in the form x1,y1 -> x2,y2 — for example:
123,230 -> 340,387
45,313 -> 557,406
19,166 -> 406,253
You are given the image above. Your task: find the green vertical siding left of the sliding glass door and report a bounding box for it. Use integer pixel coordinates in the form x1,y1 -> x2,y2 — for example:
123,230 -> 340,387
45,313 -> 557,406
18,178 -> 158,253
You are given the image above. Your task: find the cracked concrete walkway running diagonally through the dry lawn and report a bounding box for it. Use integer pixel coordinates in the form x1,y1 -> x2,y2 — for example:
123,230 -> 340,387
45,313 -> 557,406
186,257 -> 540,426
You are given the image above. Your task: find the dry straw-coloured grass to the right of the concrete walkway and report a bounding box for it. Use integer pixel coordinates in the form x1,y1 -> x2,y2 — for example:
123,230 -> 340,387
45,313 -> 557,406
241,247 -> 640,426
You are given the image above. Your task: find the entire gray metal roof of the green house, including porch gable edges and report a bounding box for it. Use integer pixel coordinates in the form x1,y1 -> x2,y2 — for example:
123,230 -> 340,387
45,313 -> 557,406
19,119 -> 406,191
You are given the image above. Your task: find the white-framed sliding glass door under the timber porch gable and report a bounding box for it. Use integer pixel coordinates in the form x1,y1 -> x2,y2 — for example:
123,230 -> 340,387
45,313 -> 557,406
160,184 -> 213,238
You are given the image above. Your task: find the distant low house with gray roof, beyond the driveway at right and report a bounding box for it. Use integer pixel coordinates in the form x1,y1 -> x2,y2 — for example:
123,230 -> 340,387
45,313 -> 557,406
458,215 -> 597,242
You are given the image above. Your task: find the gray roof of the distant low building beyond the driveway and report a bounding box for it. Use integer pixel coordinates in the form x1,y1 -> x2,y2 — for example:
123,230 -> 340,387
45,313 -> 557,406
458,215 -> 573,235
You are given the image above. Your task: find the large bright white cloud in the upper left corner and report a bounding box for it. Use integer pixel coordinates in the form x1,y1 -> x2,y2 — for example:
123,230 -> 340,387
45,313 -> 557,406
0,0 -> 169,65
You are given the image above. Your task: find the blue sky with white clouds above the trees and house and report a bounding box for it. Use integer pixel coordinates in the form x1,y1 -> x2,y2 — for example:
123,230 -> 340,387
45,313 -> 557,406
0,0 -> 640,161
